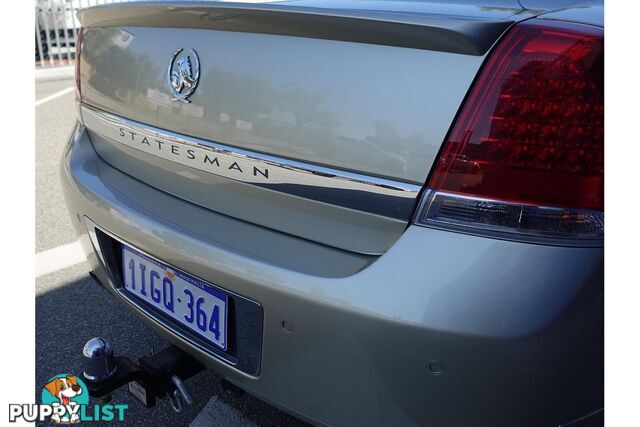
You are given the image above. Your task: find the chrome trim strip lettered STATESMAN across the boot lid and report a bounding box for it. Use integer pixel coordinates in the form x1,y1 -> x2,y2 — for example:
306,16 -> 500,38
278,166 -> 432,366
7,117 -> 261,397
81,104 -> 421,221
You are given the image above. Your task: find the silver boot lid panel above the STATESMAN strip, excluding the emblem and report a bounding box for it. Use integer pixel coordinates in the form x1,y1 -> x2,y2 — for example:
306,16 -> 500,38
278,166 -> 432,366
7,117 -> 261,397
81,27 -> 483,184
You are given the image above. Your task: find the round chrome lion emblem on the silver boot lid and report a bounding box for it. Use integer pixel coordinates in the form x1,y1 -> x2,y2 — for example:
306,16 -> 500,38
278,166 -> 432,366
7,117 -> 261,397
167,48 -> 200,104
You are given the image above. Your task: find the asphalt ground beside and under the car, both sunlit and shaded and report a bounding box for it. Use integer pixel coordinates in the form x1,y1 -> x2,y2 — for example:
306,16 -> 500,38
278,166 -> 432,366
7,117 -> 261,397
35,78 -> 306,427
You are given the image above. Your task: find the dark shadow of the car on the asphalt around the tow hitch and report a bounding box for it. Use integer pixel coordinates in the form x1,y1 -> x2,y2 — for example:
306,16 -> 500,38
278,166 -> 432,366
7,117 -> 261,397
36,275 -> 306,426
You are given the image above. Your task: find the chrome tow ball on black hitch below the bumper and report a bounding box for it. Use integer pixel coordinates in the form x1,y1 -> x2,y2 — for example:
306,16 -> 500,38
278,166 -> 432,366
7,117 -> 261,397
82,337 -> 204,412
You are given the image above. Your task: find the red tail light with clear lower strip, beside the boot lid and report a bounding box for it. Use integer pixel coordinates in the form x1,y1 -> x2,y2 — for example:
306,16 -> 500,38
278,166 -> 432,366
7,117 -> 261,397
416,19 -> 604,245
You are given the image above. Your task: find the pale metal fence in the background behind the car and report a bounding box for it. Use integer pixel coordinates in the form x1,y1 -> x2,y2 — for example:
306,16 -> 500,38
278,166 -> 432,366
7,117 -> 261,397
36,0 -> 148,67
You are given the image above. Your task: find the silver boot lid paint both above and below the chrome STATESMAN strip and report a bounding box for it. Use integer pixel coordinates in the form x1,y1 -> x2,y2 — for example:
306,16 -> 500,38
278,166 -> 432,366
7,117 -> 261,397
81,9 -> 496,254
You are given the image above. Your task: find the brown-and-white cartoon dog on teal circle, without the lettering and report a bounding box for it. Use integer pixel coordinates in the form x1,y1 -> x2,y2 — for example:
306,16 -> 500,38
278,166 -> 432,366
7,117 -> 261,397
42,374 -> 89,424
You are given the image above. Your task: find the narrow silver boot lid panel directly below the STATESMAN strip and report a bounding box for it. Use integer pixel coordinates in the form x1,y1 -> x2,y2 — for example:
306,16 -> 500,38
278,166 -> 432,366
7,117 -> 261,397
80,106 -> 415,254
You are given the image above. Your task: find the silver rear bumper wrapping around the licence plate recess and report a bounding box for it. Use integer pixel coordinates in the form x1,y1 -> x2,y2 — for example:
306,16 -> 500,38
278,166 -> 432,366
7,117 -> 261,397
62,122 -> 604,425
